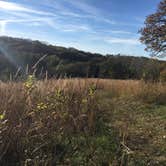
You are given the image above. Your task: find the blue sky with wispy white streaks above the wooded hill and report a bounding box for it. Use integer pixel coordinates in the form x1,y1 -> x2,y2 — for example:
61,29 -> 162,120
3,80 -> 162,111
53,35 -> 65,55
0,0 -> 160,56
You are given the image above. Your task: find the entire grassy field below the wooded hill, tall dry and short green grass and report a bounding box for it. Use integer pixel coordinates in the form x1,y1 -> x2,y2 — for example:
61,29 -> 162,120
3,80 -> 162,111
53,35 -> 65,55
0,76 -> 166,166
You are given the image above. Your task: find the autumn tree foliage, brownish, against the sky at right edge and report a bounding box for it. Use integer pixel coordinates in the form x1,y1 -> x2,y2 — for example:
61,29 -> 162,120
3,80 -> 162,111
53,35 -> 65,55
140,0 -> 166,57
